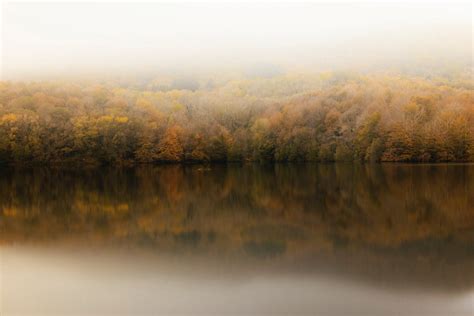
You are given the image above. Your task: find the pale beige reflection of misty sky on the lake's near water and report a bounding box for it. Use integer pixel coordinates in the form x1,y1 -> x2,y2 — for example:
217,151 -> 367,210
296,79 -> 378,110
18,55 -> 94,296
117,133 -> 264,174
0,247 -> 472,316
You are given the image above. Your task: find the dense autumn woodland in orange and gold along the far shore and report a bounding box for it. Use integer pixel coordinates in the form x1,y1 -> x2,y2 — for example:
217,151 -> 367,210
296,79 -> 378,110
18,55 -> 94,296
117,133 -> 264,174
0,71 -> 474,164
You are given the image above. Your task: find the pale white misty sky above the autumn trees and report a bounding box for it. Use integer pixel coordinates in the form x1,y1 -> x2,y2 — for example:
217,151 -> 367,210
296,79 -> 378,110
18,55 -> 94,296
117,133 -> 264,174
1,1 -> 472,79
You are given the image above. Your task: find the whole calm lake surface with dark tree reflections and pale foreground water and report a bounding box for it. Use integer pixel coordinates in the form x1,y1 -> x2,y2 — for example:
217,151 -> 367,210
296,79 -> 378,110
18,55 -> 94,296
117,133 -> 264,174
0,164 -> 474,316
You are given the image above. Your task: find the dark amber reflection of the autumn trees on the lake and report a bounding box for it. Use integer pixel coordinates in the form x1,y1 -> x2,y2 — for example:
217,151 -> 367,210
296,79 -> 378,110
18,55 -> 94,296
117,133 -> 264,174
0,164 -> 474,314
